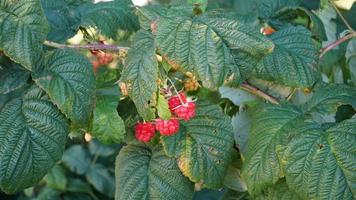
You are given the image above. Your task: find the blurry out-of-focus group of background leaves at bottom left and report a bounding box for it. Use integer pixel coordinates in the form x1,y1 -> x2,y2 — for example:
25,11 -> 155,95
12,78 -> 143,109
10,140 -> 121,200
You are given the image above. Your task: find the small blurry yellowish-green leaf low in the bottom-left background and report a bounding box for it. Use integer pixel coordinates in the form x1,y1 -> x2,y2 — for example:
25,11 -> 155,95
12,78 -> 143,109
44,165 -> 68,191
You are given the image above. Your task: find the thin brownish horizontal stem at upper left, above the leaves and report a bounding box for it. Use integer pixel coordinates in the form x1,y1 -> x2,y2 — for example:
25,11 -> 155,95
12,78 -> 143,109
44,40 -> 129,51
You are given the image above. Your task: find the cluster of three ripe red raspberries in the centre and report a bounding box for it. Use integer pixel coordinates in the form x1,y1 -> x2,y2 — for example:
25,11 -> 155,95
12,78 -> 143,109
135,92 -> 195,142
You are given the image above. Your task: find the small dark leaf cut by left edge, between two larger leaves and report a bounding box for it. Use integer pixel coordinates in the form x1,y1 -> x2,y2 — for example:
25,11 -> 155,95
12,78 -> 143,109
0,62 -> 30,94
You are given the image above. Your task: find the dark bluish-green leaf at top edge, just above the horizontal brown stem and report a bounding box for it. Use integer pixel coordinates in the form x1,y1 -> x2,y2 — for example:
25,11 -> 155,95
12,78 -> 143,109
77,0 -> 139,38
